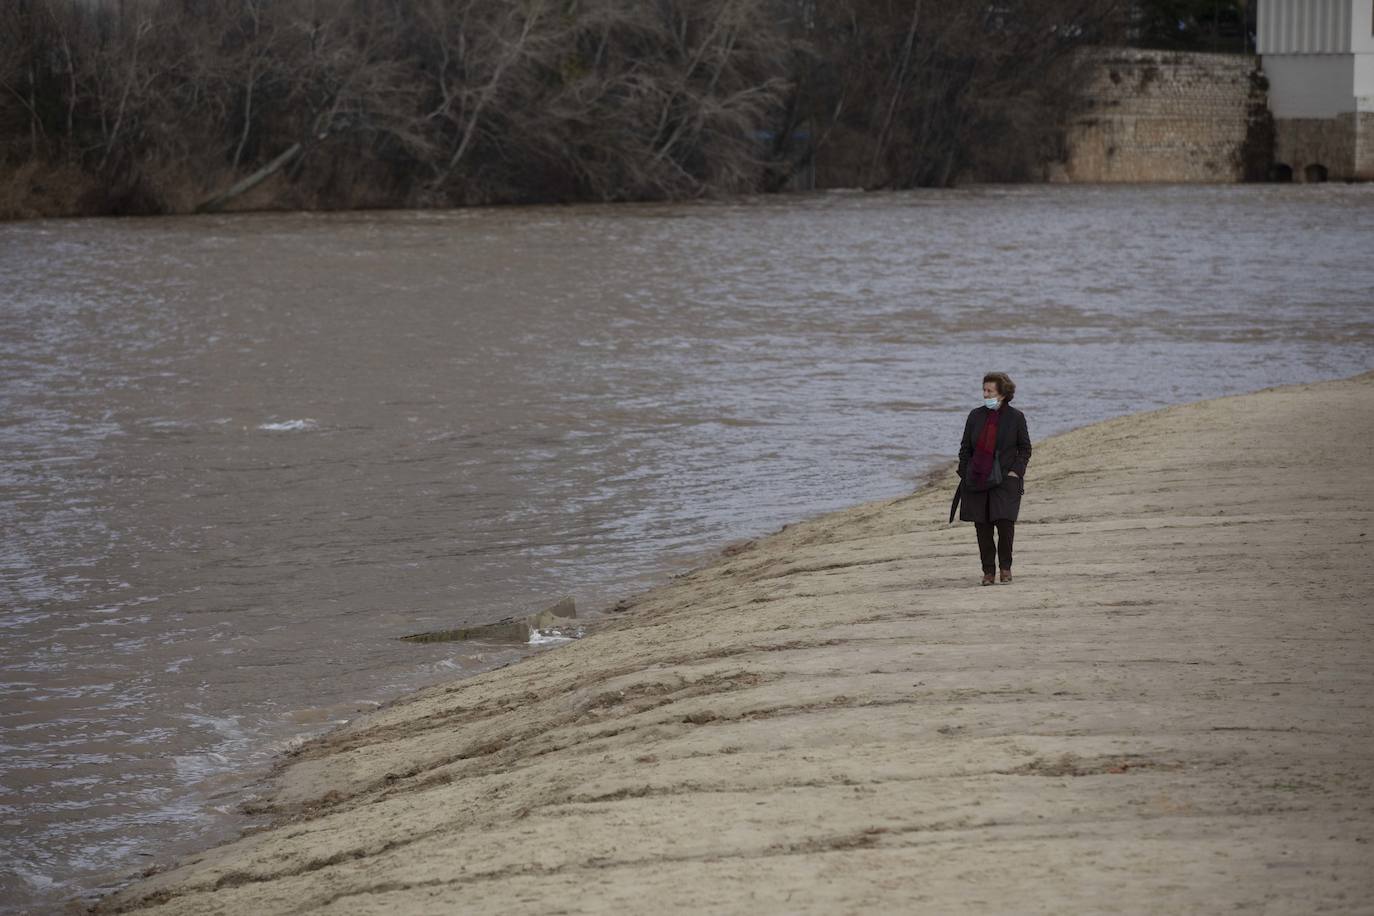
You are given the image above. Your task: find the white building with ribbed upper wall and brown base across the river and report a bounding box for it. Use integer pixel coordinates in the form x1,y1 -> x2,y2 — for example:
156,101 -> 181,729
1257,0 -> 1374,181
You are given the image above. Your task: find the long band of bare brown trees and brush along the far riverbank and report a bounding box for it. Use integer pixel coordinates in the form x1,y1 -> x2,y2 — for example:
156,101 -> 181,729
0,0 -> 1127,218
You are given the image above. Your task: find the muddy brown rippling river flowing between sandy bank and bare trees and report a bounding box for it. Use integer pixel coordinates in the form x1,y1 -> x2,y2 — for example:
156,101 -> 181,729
8,185 -> 1374,912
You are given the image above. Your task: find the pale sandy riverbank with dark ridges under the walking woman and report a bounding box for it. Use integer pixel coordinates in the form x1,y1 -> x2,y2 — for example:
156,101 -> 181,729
100,374 -> 1374,916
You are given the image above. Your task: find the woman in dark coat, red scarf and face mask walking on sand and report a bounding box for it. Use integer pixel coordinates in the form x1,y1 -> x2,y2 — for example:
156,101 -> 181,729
956,372 -> 1031,585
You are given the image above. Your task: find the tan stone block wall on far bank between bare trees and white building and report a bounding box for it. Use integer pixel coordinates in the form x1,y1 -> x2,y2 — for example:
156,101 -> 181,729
1051,48 -> 1272,181
